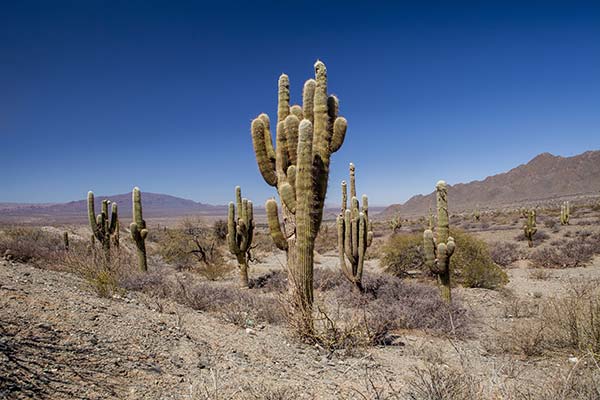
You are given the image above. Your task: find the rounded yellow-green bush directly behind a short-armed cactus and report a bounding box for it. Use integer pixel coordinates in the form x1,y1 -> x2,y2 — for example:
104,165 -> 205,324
381,229 -> 508,289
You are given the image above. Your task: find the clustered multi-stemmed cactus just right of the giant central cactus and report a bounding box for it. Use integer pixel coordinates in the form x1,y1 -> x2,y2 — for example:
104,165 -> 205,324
337,163 -> 373,292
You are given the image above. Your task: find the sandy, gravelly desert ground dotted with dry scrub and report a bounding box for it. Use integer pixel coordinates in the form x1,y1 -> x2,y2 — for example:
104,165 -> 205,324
0,200 -> 600,399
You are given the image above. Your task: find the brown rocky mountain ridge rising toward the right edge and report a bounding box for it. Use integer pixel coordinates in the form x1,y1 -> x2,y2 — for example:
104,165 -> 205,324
380,151 -> 600,217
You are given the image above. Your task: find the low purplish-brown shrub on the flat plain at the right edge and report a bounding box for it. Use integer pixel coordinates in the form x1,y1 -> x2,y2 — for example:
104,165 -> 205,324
530,234 -> 600,268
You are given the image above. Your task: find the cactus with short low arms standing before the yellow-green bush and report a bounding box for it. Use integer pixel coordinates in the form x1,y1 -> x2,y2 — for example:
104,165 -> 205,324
423,181 -> 456,302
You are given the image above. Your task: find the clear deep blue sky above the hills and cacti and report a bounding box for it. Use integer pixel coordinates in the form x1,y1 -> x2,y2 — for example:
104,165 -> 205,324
0,0 -> 600,205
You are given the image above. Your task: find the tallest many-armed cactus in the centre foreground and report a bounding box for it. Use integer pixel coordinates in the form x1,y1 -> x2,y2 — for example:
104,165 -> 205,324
252,61 -> 347,310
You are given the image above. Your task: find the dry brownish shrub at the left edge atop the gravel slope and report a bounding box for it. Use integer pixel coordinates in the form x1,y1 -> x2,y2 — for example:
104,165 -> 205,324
0,227 -> 64,262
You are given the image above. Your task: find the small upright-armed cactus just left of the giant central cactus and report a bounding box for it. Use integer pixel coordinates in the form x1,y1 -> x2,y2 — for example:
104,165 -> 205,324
227,186 -> 254,288
